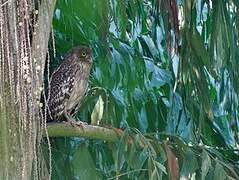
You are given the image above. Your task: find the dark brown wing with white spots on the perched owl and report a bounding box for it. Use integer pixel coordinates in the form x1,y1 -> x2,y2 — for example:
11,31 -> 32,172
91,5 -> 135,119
47,63 -> 75,120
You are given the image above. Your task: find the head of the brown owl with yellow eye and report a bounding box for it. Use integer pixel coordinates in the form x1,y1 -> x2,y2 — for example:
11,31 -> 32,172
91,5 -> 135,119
72,46 -> 93,63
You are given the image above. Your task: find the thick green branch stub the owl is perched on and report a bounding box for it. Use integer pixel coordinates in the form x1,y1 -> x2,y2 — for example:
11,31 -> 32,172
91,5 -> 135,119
47,122 -> 123,142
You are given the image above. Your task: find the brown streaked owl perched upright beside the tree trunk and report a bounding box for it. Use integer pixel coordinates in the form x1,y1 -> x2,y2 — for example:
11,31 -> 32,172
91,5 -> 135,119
47,46 -> 92,122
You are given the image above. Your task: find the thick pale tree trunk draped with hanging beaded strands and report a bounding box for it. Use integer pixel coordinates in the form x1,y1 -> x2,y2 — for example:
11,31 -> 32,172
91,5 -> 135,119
0,0 -> 55,179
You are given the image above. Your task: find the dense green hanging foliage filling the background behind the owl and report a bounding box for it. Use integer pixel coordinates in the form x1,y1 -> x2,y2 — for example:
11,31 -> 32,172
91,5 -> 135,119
46,0 -> 239,179
